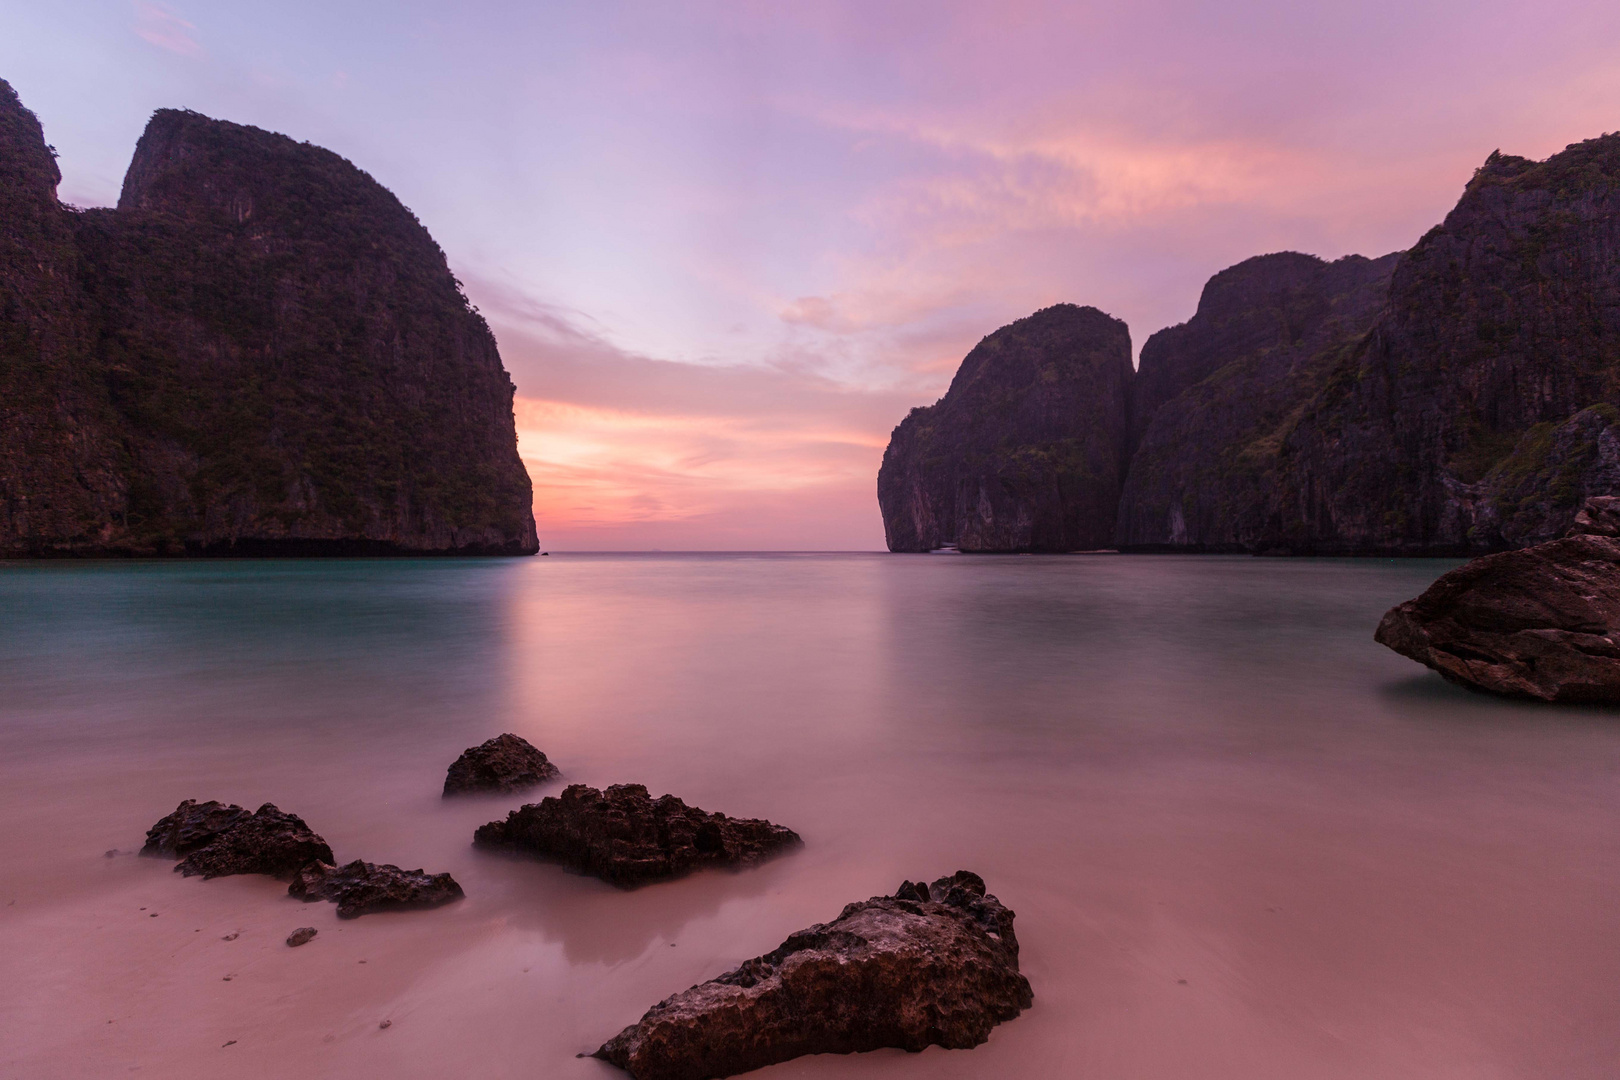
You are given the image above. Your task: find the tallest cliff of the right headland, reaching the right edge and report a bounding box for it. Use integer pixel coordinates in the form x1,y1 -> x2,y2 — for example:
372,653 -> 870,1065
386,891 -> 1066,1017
1277,134 -> 1620,554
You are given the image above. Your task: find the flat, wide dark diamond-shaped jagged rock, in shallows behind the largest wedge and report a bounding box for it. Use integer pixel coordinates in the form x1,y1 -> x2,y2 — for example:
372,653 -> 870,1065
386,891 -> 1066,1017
473,784 -> 802,889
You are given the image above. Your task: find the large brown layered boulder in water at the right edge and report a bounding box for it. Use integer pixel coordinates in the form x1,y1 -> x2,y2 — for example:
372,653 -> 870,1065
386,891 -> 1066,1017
1374,497 -> 1620,704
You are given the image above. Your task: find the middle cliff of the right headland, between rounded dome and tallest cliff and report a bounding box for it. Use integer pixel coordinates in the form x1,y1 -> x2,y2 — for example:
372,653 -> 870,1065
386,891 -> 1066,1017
1118,253 -> 1400,551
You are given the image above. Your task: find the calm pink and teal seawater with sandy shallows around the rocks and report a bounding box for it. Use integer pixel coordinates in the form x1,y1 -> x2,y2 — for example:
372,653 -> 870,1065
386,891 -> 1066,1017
0,555 -> 1620,1080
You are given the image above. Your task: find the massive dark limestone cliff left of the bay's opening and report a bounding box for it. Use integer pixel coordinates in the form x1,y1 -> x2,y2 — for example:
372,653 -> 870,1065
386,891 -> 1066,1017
0,81 -> 539,557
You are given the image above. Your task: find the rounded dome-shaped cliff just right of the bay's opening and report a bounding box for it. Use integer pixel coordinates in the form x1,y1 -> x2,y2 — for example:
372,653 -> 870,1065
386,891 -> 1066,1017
878,304 -> 1132,551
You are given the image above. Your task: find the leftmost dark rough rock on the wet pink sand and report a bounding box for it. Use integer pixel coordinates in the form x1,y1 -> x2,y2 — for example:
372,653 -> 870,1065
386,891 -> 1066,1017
143,798 -> 335,878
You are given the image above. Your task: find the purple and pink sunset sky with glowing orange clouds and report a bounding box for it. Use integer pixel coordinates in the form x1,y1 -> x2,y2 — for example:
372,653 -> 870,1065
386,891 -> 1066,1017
0,0 -> 1620,551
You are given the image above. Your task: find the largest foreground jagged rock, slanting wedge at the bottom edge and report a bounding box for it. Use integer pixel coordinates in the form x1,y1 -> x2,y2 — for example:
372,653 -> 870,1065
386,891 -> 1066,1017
595,871 -> 1034,1080
